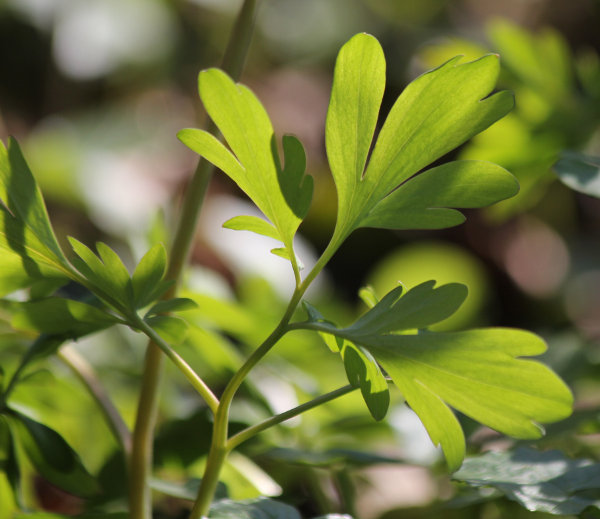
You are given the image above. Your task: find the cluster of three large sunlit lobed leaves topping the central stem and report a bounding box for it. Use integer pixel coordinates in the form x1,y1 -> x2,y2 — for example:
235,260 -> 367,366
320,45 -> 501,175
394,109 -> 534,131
179,34 -> 572,470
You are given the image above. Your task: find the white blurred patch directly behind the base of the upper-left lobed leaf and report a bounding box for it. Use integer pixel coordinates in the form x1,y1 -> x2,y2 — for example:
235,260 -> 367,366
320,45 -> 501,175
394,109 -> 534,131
200,195 -> 319,299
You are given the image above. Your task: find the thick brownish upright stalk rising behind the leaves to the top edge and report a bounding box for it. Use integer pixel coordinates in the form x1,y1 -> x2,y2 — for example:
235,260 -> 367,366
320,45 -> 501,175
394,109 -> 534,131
129,0 -> 257,519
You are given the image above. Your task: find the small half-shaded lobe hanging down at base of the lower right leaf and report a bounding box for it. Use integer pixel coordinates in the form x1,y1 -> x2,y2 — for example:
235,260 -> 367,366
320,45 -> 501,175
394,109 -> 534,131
341,341 -> 390,420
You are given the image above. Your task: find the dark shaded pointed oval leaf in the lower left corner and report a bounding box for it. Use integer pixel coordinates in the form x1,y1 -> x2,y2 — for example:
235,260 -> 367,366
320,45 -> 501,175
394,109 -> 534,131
8,410 -> 99,497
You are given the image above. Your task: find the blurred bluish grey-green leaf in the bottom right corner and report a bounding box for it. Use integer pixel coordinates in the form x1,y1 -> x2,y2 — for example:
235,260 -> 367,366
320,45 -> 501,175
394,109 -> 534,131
453,448 -> 600,515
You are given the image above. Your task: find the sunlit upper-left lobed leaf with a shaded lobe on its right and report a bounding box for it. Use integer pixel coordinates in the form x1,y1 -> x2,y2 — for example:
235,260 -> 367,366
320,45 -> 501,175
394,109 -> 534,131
178,69 -> 313,270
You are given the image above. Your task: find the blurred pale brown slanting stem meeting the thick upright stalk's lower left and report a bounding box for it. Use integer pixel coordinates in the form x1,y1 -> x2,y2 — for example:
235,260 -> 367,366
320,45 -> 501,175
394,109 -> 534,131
58,345 -> 131,457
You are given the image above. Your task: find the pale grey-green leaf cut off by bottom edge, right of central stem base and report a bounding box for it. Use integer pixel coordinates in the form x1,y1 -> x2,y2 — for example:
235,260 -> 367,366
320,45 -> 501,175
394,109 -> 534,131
208,497 -> 301,519
